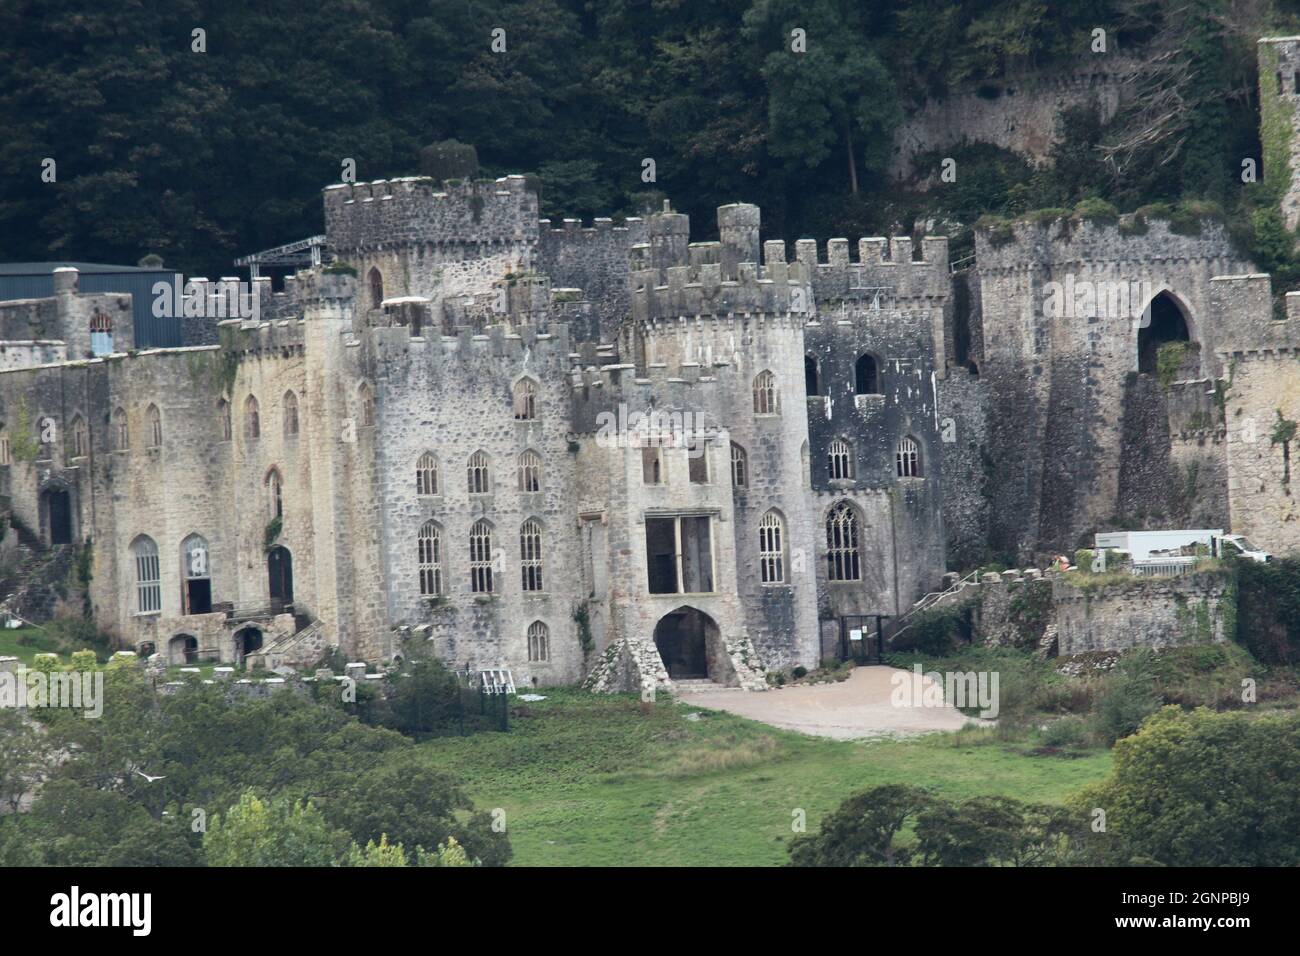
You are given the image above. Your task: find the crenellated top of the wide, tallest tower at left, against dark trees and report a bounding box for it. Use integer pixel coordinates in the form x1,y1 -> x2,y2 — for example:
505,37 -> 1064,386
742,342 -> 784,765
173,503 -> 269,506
324,176 -> 538,256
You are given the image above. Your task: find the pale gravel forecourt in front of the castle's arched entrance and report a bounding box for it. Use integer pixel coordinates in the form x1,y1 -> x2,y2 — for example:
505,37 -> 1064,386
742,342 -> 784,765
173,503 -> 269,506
681,667 -> 992,740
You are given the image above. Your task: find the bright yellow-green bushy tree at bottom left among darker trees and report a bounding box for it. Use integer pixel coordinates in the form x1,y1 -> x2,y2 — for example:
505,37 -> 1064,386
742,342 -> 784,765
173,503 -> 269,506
203,790 -> 348,866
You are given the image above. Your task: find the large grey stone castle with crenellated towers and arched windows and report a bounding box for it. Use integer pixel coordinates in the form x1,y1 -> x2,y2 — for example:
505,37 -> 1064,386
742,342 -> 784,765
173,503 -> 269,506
0,39 -> 1300,689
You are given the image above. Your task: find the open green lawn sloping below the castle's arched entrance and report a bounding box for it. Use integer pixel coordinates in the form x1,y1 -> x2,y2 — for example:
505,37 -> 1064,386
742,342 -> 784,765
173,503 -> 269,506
421,689 -> 1110,865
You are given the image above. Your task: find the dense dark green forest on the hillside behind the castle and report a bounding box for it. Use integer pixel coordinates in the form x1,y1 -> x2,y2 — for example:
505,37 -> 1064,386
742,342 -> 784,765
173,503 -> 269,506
0,0 -> 1300,278
